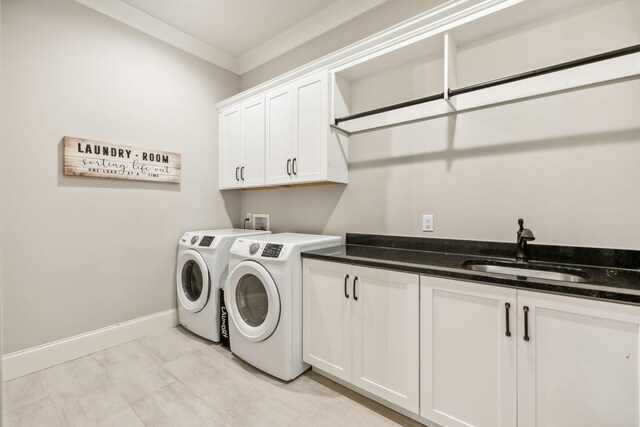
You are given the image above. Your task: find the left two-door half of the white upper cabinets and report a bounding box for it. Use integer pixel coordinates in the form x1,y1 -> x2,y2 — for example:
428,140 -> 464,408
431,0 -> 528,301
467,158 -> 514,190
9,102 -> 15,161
218,96 -> 265,189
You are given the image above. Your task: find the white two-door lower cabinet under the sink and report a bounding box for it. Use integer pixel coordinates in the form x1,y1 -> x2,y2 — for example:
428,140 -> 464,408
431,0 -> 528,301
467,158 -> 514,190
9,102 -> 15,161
420,276 -> 640,427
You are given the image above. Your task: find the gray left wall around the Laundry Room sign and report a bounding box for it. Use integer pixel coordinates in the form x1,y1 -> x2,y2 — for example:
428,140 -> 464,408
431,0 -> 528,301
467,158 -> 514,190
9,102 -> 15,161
0,0 -> 240,354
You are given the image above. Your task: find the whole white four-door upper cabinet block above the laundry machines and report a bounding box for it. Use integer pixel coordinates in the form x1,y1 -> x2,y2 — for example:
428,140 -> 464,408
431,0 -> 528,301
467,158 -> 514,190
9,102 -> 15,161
218,72 -> 348,189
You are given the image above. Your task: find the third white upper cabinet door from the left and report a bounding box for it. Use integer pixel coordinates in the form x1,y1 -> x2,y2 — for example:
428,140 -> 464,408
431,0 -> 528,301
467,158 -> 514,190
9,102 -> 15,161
265,86 -> 293,185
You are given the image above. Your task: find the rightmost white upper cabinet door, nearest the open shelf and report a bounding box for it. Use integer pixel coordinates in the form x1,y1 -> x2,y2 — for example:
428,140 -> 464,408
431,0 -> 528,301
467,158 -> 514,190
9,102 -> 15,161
292,72 -> 329,182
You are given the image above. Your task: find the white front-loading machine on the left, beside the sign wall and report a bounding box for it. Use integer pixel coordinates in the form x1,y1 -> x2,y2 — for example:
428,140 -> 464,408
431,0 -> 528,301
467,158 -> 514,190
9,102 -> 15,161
176,229 -> 271,342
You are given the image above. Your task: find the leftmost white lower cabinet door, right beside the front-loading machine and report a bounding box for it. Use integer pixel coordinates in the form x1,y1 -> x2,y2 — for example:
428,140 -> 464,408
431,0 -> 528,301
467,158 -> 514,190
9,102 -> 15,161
302,259 -> 352,381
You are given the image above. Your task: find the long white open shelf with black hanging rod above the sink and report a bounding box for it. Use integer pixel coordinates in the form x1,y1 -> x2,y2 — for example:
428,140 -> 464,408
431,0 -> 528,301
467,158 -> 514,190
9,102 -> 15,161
330,0 -> 640,134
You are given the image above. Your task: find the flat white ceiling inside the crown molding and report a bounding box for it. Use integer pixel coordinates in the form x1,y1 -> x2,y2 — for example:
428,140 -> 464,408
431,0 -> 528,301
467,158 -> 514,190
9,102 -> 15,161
76,0 -> 387,74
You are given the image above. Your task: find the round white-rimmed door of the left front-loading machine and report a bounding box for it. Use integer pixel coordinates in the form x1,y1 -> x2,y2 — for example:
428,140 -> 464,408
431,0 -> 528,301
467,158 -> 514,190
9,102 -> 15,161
176,249 -> 211,313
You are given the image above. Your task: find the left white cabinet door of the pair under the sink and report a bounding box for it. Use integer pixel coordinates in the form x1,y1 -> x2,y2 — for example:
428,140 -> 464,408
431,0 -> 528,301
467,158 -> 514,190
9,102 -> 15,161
420,276 -> 516,427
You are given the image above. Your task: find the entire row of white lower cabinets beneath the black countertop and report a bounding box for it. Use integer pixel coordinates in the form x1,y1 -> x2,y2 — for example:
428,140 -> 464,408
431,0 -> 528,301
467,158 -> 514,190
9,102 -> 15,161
303,259 -> 640,427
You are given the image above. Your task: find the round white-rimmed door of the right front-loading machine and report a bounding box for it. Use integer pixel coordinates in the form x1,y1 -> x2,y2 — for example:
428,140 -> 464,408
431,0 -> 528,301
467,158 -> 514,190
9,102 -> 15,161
224,261 -> 280,342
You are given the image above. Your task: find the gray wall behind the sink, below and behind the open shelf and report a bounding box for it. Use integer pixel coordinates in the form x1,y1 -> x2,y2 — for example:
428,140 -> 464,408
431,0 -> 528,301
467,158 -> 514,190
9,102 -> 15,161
241,2 -> 640,249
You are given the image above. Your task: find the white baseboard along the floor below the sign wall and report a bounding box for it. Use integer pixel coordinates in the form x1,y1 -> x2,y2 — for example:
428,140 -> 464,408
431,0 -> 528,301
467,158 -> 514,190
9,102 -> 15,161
2,308 -> 178,381
